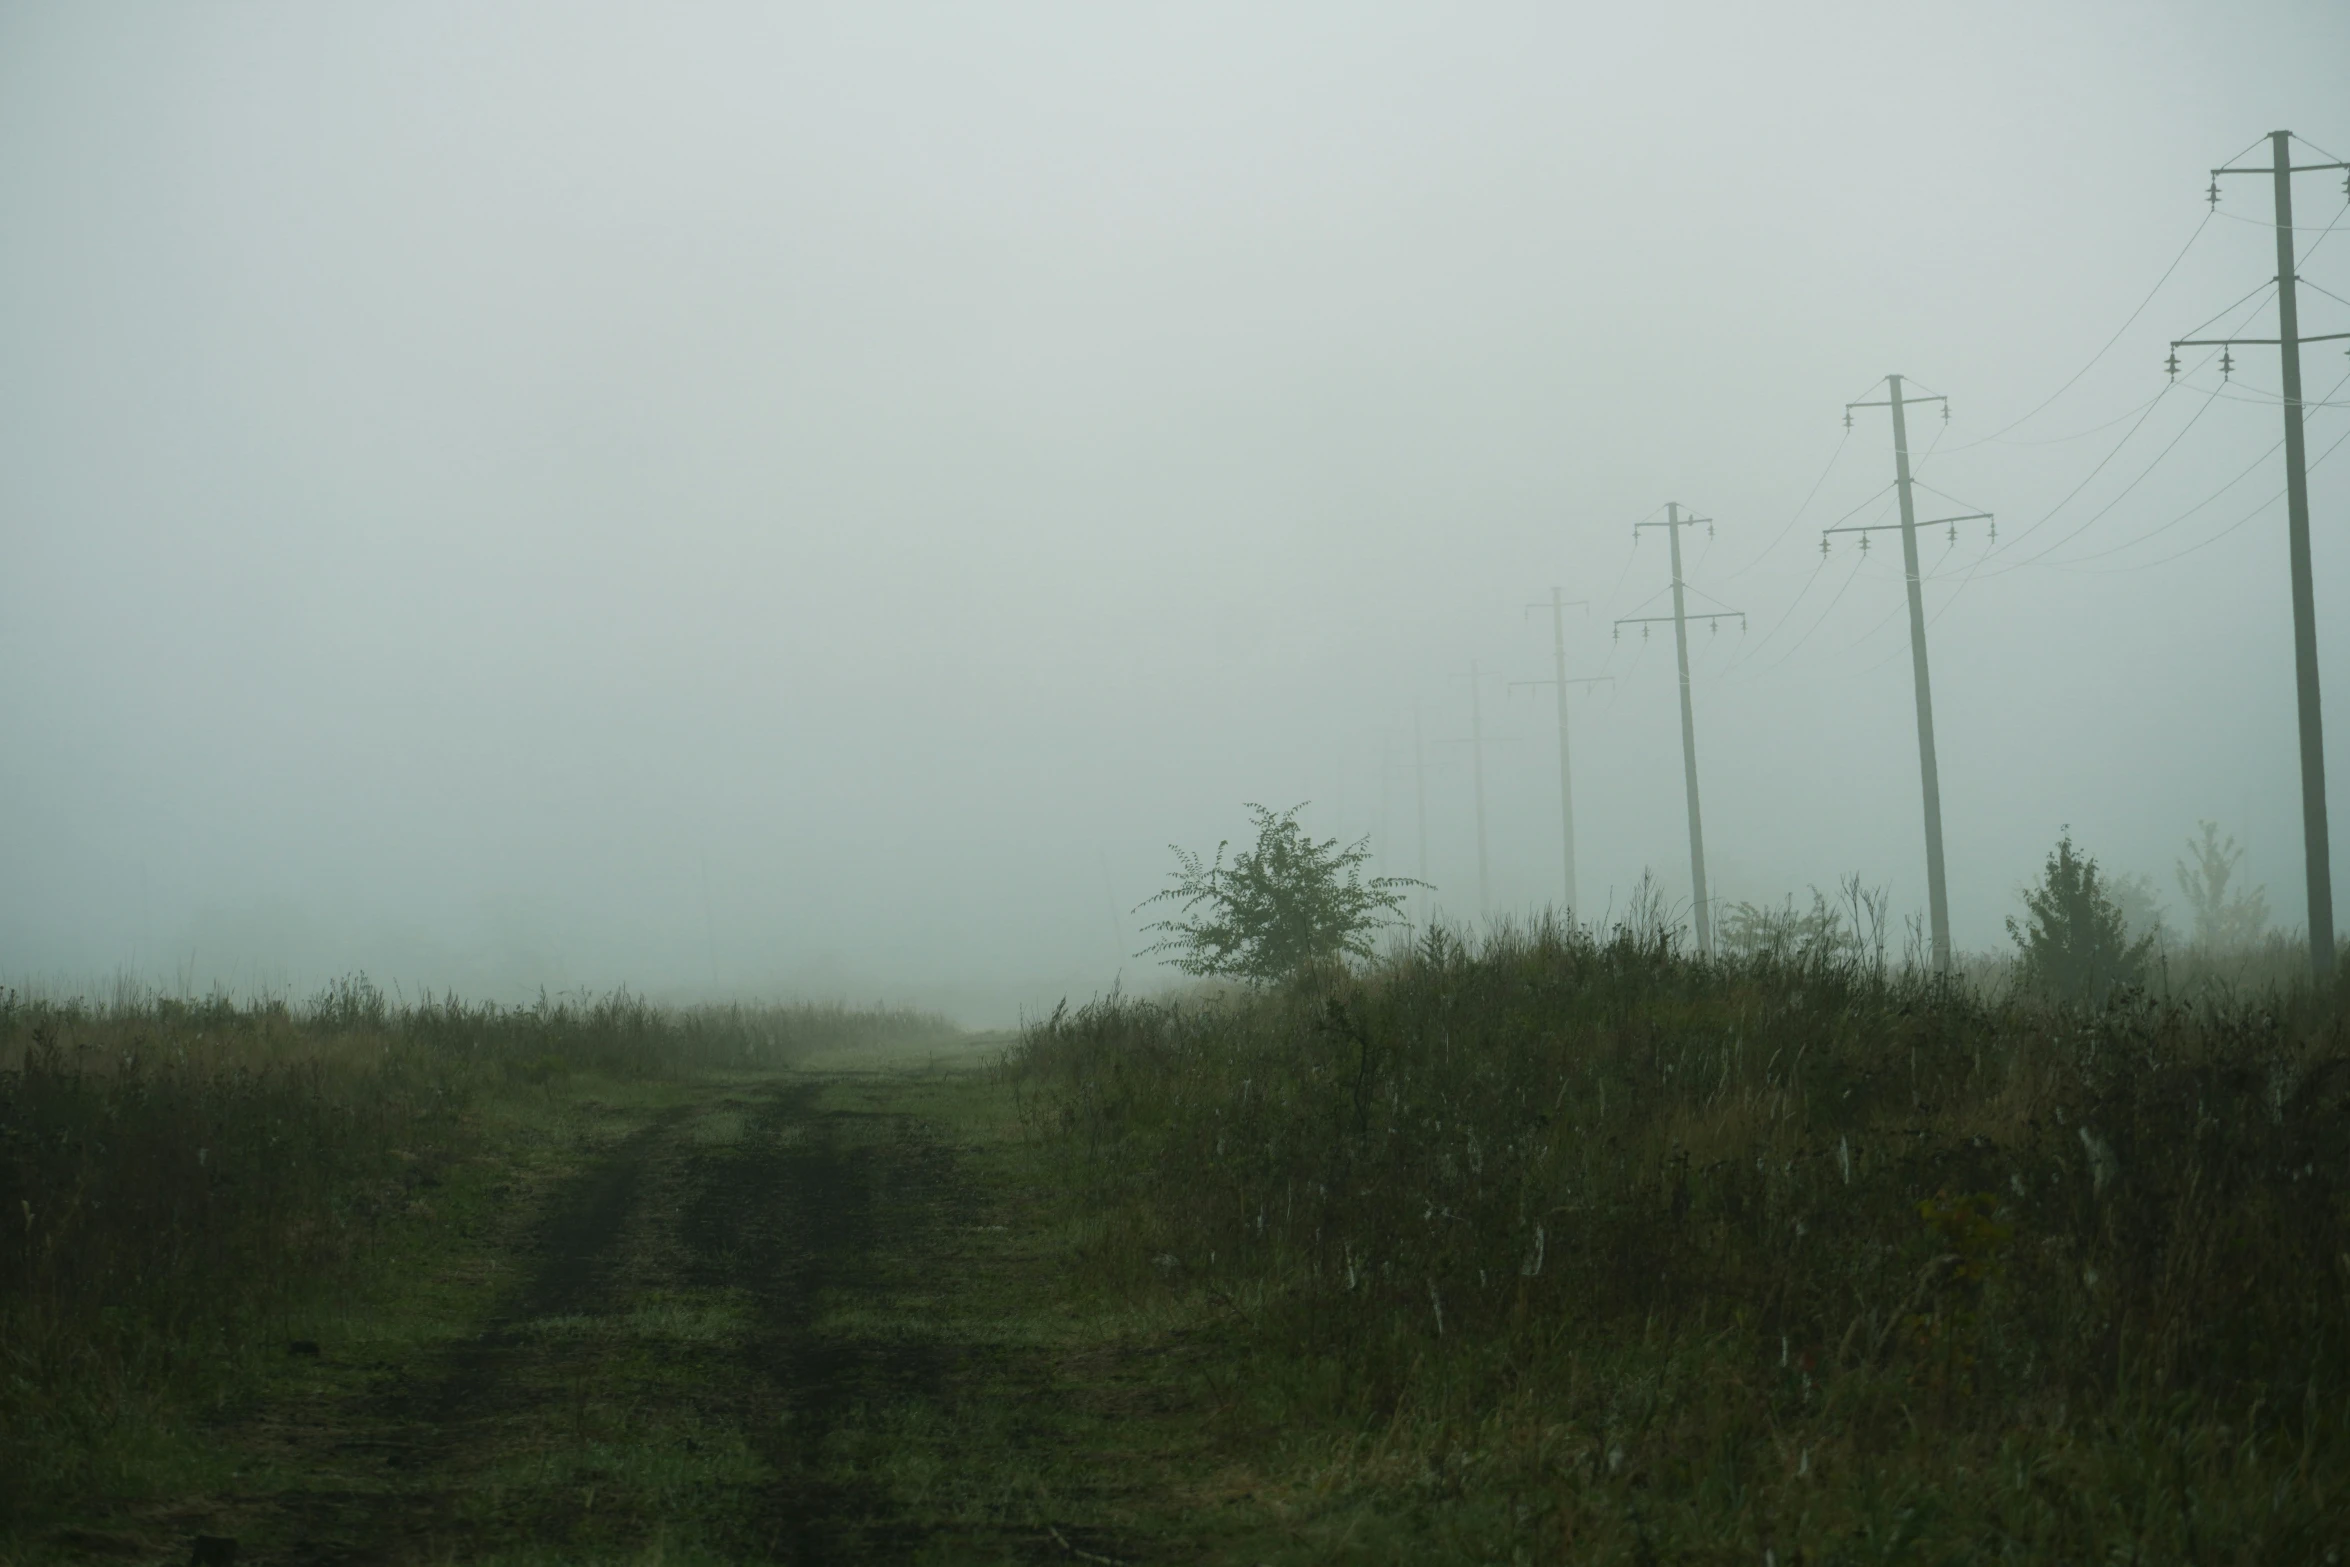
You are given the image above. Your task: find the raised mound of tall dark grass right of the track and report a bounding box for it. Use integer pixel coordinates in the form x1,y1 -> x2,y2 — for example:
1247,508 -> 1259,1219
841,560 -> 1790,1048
1015,933 -> 2350,1562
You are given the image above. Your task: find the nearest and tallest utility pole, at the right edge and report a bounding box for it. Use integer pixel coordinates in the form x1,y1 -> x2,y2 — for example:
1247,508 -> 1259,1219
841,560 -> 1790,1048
2169,132 -> 2350,982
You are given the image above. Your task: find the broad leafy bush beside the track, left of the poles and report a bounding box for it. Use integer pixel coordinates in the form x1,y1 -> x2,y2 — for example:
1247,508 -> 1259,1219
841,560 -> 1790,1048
1137,803 -> 1424,984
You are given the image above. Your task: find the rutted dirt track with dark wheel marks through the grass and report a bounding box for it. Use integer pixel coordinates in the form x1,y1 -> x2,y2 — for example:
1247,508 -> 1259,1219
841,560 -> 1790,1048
94,1074 -> 1189,1567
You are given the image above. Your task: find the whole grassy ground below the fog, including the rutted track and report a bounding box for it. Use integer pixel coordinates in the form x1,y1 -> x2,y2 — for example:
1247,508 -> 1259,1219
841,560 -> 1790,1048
13,933 -> 2350,1565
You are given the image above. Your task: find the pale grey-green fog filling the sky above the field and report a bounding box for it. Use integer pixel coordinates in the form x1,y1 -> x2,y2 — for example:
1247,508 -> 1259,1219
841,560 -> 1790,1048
0,0 -> 2350,1022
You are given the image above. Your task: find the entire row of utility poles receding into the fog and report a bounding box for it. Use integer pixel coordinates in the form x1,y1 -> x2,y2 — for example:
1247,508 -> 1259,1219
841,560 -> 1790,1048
1412,132 -> 2350,980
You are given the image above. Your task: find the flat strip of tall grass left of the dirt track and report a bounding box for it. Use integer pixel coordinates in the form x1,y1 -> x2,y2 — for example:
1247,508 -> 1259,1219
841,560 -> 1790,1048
0,980 -> 954,1527
